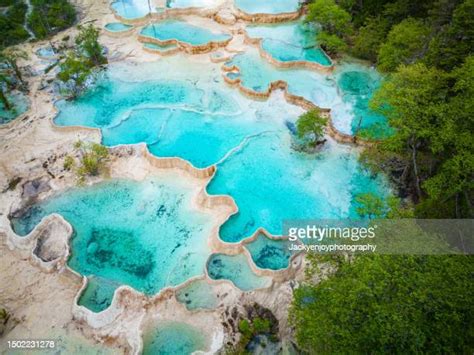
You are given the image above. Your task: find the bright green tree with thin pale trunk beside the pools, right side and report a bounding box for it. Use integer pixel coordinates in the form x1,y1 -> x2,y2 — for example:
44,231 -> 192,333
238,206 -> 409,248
370,64 -> 448,200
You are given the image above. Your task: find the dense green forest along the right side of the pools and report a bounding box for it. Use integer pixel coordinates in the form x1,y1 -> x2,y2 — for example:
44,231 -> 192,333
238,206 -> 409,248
290,0 -> 474,354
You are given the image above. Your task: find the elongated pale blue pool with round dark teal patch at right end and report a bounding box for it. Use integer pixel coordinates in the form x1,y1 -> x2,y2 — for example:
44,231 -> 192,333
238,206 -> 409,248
228,49 -> 391,136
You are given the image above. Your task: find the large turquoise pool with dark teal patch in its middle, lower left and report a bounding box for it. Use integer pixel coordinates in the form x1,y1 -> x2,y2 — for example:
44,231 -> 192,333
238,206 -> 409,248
12,177 -> 213,311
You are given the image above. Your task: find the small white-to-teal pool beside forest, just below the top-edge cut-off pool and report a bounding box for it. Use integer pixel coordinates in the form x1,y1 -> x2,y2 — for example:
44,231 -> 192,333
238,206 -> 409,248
246,21 -> 331,66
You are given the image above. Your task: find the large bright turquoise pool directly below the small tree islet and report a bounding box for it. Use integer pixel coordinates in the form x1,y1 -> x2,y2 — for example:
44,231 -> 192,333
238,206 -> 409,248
208,134 -> 384,242
